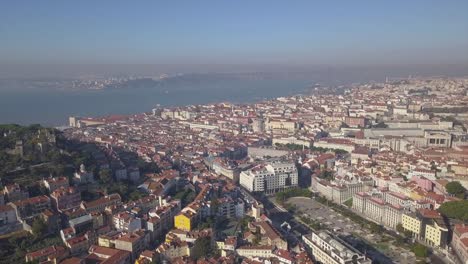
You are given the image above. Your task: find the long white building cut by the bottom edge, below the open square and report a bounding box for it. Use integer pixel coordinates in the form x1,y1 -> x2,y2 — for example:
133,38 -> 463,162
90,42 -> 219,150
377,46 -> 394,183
302,231 -> 372,264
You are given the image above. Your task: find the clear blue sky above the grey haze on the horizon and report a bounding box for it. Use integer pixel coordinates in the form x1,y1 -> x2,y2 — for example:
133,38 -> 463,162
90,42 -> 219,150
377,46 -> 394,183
0,0 -> 468,64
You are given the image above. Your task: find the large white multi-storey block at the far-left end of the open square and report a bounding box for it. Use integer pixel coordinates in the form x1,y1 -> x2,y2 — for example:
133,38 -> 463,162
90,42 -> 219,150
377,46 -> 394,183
240,161 -> 298,194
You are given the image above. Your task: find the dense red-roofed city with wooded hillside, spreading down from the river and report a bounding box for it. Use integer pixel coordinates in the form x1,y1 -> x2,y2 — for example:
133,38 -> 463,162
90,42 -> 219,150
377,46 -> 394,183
0,77 -> 468,264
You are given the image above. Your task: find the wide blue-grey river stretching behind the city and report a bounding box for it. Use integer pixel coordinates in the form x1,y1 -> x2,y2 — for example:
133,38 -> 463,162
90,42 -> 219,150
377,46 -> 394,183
0,79 -> 312,126
